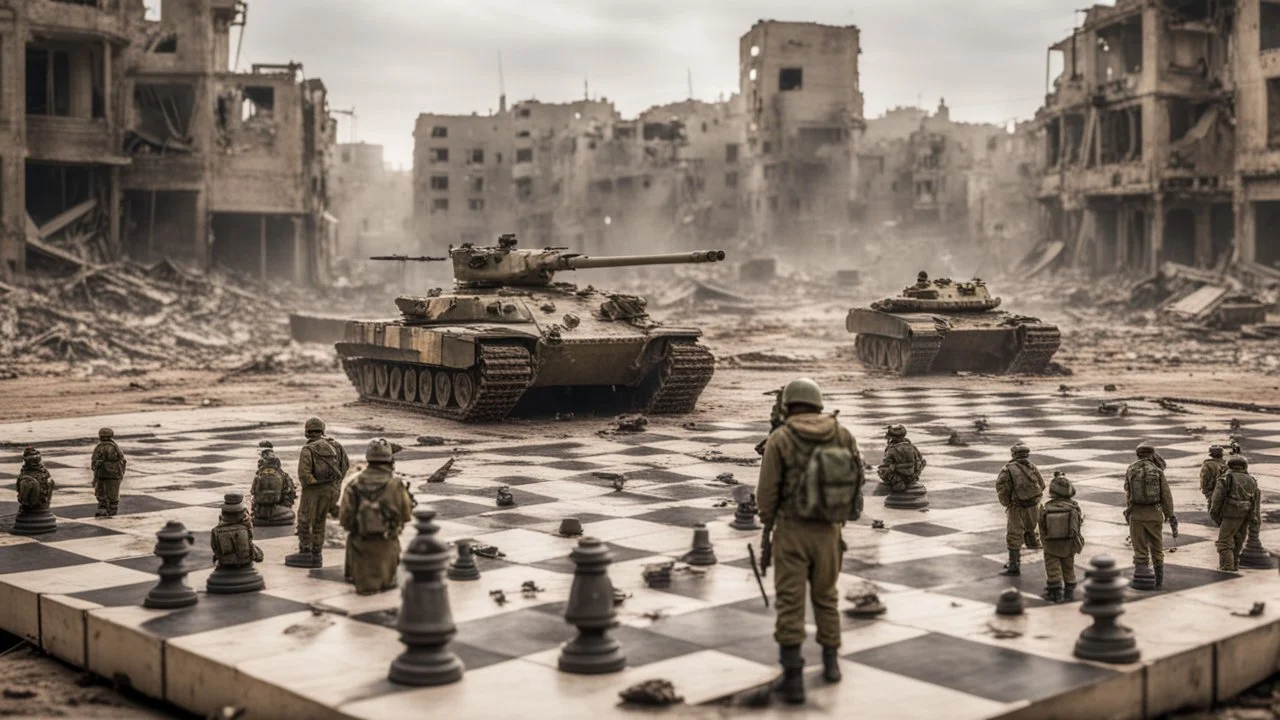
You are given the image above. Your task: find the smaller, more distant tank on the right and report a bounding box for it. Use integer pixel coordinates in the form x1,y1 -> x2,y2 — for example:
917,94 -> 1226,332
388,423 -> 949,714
845,273 -> 1061,375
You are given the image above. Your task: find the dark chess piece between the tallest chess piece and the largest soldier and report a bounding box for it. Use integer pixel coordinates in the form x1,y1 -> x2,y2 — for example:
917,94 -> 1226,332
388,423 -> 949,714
559,538 -> 627,675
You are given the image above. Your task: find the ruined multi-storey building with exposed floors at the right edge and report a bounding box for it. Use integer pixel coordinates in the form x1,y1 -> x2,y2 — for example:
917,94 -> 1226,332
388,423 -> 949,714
1037,0 -> 1280,273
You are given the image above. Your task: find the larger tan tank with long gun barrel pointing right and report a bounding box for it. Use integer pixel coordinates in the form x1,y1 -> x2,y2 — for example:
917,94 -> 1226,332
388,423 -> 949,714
337,234 -> 724,423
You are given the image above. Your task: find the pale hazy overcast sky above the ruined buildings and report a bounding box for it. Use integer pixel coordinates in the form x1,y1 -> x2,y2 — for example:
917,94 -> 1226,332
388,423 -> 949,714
232,0 -> 1082,168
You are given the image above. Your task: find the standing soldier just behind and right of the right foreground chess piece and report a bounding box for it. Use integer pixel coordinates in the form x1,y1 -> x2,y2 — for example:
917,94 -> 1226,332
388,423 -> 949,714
1124,443 -> 1178,589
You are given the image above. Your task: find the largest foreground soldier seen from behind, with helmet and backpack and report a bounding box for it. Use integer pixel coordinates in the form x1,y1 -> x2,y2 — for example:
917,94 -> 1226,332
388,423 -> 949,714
756,379 -> 863,703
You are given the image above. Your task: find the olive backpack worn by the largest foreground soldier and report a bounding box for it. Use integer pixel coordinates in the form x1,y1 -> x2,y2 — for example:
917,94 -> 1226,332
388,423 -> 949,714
787,425 -> 864,523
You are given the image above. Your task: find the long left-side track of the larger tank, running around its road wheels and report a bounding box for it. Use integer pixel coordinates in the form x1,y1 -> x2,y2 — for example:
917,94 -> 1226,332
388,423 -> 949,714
343,343 -> 534,423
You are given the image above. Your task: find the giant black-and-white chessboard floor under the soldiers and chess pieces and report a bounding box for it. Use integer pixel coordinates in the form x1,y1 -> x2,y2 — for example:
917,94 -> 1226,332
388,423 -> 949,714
0,388 -> 1280,719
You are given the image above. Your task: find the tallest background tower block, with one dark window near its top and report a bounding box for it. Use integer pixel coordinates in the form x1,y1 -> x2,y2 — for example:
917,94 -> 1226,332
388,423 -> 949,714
739,20 -> 865,247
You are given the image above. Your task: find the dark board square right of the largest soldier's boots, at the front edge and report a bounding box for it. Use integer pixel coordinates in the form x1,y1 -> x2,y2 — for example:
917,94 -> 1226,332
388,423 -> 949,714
845,633 -> 1115,702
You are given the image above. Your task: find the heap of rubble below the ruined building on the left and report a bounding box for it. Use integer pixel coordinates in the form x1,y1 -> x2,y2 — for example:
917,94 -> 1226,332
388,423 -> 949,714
0,260 -> 335,377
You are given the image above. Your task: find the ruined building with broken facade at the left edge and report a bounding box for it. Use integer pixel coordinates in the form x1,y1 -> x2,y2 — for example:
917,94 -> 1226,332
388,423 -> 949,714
0,0 -> 334,283
